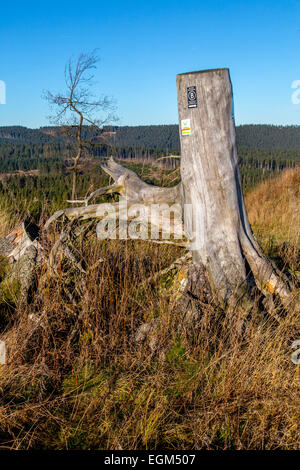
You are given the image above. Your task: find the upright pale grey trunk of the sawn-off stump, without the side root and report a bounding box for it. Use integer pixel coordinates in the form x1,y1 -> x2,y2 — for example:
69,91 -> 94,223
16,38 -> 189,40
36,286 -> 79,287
177,69 -> 289,302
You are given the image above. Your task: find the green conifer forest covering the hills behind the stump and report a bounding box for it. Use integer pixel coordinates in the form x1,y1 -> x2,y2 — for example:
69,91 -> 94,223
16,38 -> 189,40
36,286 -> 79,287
0,125 -> 300,221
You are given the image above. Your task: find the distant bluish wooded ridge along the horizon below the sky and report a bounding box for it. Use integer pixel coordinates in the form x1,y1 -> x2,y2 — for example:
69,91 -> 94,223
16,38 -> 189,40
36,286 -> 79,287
0,124 -> 300,151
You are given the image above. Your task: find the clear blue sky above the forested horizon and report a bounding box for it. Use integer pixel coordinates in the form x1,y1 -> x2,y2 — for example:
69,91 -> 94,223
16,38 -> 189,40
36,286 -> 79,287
0,0 -> 300,127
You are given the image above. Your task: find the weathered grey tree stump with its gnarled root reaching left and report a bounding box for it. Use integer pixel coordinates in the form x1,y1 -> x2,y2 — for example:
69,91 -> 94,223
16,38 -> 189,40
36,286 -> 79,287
45,69 -> 291,305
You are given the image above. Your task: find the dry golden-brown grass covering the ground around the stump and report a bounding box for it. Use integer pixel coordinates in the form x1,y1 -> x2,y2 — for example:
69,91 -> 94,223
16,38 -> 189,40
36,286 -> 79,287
0,170 -> 300,449
